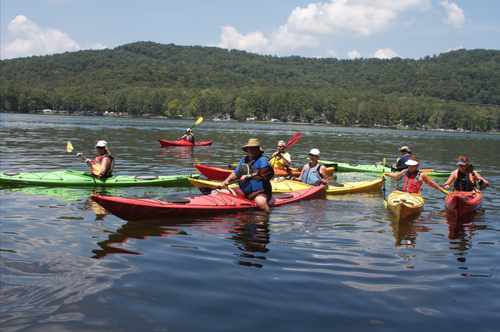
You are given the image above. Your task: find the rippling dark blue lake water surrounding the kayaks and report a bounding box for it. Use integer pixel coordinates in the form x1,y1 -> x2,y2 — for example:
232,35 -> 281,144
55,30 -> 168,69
0,114 -> 500,332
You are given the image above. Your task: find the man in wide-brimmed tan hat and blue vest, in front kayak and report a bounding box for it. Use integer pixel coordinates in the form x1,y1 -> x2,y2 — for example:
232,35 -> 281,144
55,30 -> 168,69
221,138 -> 272,212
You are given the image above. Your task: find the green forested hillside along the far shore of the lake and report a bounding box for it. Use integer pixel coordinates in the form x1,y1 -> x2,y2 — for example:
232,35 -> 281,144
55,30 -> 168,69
0,42 -> 500,130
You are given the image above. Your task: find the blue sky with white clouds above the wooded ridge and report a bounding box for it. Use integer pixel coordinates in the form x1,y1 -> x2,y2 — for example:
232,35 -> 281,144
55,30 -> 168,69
0,0 -> 500,59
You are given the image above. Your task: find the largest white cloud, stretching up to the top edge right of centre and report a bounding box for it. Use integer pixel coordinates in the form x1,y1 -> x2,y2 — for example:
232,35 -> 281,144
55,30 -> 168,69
215,0 -> 431,54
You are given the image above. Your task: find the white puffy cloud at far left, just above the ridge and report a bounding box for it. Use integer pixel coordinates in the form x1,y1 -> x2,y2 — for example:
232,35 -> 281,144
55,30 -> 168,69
2,15 -> 81,59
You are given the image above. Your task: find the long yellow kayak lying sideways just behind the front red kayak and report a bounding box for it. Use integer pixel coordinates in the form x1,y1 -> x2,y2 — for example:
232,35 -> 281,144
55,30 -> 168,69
188,178 -> 382,195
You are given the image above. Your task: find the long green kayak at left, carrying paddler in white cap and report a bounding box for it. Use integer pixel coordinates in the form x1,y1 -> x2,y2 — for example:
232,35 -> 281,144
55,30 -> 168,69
0,170 -> 200,187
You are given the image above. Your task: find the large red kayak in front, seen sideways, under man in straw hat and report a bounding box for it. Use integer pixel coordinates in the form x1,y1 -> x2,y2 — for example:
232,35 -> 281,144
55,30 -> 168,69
90,186 -> 324,221
